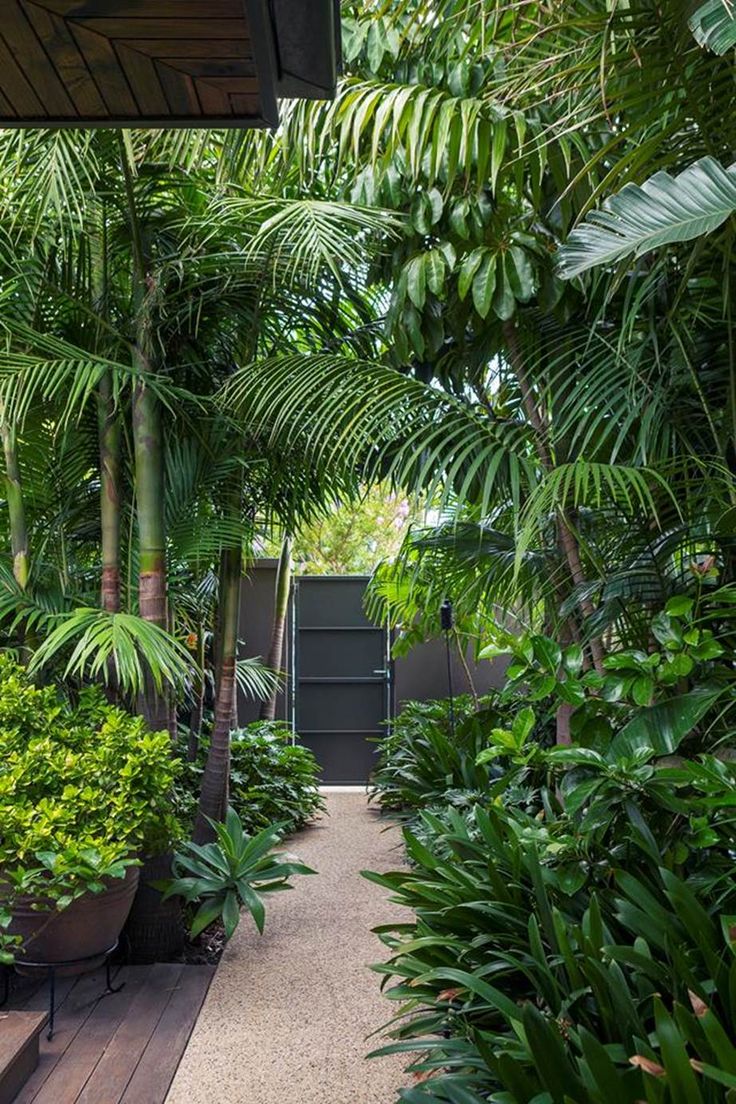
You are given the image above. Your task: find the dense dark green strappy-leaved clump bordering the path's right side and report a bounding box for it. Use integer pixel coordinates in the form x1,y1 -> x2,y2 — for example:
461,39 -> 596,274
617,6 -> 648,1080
369,749 -> 736,1104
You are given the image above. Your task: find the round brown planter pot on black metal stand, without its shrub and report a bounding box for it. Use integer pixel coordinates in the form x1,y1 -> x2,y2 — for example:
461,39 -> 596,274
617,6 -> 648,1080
5,867 -> 139,977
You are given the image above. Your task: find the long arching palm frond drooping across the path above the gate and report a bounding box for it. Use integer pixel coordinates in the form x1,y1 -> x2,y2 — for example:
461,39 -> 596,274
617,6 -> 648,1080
221,354 -> 535,513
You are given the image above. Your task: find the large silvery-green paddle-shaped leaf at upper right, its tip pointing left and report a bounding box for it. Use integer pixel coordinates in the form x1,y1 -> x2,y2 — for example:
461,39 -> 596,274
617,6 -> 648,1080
558,157 -> 736,279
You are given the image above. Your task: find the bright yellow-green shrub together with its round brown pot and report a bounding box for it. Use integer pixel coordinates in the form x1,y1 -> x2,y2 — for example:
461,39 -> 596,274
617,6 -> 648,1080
0,657 -> 178,972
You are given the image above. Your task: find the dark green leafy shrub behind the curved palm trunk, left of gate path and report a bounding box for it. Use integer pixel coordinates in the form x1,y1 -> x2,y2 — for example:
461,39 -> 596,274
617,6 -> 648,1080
177,721 -> 324,834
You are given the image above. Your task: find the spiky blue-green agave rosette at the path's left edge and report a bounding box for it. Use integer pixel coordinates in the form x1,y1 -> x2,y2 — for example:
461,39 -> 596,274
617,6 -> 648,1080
164,807 -> 316,940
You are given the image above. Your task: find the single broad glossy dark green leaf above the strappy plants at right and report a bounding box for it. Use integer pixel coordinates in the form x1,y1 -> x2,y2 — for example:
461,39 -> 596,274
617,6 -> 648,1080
606,688 -> 723,761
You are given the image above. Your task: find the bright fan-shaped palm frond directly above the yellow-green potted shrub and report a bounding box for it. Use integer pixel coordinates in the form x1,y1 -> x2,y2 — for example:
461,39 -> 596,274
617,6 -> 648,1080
29,607 -> 192,694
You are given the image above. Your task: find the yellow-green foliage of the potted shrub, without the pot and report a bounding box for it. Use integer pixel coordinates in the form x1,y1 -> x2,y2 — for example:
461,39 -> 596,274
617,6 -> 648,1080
0,656 -> 178,906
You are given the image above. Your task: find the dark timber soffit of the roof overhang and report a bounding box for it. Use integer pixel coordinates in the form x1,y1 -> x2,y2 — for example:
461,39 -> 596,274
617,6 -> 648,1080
0,0 -> 340,127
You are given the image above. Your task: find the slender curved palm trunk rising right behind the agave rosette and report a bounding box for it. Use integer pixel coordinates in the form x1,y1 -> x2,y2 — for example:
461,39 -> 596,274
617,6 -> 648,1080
194,538 -> 243,843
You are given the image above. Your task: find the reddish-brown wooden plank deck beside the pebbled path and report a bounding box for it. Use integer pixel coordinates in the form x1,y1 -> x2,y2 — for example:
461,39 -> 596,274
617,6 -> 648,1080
8,964 -> 214,1104
